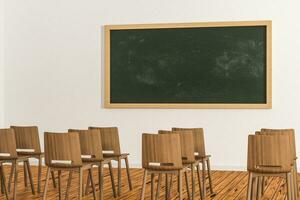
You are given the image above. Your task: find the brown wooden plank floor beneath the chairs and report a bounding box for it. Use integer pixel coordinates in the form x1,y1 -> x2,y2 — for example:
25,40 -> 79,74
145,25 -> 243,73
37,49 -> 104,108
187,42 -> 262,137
0,167 -> 298,200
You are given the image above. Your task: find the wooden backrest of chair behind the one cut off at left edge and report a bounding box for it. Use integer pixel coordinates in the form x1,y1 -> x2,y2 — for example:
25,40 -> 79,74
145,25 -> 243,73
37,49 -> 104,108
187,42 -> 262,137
10,126 -> 41,153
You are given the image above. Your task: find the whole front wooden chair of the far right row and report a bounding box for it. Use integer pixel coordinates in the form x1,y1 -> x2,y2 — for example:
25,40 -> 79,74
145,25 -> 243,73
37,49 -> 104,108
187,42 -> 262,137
247,135 -> 296,200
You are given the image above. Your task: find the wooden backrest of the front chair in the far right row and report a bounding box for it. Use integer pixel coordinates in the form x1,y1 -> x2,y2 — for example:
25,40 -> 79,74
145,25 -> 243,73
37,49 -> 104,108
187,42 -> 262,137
247,135 -> 293,173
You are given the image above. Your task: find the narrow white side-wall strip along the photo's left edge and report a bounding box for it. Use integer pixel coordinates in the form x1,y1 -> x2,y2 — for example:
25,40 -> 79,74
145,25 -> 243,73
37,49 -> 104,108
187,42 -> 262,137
0,0 -> 4,127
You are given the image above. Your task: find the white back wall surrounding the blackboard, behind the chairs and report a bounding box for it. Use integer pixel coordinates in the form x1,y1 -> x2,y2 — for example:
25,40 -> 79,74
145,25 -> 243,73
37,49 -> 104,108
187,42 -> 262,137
5,0 -> 300,169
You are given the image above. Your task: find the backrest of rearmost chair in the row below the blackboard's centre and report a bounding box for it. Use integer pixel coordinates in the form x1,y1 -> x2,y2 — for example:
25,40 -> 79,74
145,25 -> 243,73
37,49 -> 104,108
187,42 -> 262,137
172,128 -> 206,157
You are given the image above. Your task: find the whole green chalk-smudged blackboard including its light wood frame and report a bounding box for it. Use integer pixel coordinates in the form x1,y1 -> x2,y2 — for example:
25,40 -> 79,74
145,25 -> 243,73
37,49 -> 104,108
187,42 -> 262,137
105,21 -> 271,108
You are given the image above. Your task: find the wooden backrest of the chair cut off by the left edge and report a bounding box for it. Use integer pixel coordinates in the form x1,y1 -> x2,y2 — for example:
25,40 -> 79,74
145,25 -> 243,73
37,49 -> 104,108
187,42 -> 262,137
0,128 -> 18,160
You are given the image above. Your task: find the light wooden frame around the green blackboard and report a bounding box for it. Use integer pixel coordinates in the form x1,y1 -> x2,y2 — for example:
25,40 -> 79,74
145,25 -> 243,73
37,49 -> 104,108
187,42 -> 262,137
104,21 -> 272,109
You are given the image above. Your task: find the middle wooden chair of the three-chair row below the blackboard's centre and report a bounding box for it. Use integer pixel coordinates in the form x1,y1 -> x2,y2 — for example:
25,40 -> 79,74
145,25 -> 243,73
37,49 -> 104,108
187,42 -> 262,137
158,130 -> 204,199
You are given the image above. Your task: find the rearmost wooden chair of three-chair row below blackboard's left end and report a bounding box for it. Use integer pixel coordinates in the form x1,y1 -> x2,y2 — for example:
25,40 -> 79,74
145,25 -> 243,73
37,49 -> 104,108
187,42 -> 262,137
89,127 -> 132,196
